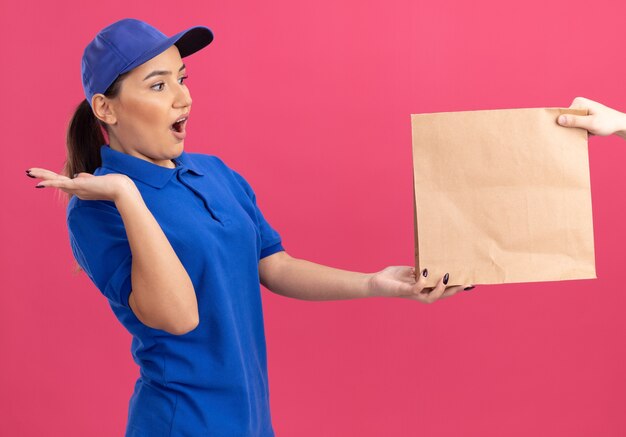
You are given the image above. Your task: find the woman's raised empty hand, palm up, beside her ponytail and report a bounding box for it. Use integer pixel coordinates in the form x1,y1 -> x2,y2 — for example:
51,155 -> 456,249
26,167 -> 134,202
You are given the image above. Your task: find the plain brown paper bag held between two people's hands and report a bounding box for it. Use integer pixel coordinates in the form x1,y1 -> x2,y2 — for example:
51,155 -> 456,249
411,108 -> 596,287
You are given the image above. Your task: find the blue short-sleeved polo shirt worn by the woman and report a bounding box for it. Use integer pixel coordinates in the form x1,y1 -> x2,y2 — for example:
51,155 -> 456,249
66,144 -> 284,437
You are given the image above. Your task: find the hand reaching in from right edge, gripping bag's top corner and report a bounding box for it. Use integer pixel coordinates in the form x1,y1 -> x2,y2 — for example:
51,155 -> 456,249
557,97 -> 626,139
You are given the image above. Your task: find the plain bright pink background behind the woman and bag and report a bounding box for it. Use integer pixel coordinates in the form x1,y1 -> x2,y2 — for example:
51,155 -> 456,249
0,0 -> 626,437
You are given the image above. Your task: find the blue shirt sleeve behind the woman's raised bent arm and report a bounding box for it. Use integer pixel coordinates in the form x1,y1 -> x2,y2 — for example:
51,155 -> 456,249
67,201 -> 132,309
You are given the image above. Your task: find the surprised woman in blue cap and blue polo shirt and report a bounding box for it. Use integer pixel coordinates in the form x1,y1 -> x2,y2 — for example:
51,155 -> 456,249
27,19 -> 465,437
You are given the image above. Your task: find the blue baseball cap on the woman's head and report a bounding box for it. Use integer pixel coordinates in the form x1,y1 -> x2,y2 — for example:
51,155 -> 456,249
81,18 -> 213,106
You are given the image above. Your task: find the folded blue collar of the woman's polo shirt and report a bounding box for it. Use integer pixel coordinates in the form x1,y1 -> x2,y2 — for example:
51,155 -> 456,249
100,144 -> 204,188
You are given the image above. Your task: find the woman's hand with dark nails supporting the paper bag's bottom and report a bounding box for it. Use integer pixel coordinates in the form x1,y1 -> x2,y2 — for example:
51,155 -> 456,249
368,266 -> 474,303
